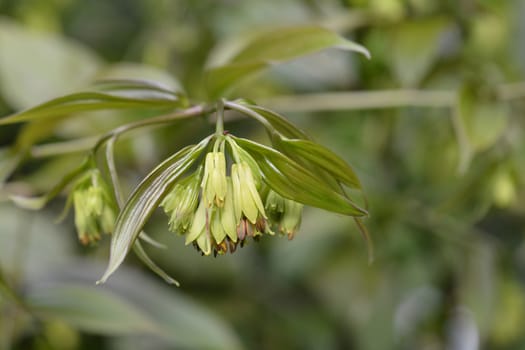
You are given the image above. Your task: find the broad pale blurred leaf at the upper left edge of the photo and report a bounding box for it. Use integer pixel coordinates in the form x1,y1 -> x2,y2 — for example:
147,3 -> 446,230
0,17 -> 103,110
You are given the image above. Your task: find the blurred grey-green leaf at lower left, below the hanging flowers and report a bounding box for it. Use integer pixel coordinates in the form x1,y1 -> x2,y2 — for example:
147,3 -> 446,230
26,284 -> 155,335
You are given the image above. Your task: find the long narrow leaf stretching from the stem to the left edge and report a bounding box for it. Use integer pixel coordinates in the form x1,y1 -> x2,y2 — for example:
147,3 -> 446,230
0,80 -> 188,125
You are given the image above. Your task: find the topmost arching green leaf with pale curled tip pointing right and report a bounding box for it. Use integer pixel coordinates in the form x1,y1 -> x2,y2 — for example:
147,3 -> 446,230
207,26 -> 370,98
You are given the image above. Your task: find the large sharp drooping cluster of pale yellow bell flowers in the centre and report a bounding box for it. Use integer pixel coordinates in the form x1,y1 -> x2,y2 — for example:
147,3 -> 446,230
161,136 -> 303,255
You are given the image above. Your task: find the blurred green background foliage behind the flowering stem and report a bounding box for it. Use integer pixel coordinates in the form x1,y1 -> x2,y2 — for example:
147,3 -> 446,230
0,0 -> 525,350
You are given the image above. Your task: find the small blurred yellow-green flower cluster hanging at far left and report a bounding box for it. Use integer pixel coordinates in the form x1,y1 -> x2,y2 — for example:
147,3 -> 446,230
70,169 -> 117,245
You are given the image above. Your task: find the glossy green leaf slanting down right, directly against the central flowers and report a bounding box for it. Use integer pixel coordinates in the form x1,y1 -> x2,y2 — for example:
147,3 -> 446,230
231,138 -> 367,216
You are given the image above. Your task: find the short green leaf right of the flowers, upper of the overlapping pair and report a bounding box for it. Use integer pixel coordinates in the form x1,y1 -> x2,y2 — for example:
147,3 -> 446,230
276,138 -> 362,190
